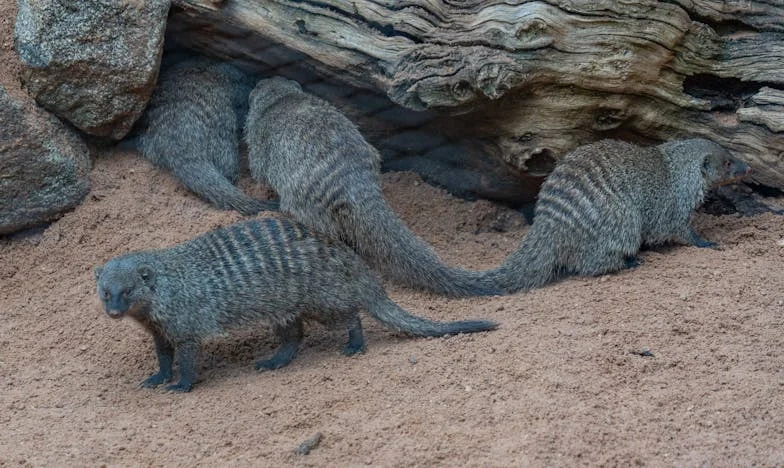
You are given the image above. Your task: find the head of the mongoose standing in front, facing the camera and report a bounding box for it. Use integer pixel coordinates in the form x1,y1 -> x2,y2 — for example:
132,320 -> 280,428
95,257 -> 155,318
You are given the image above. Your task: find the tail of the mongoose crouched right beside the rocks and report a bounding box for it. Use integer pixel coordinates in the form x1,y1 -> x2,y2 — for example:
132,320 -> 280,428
172,160 -> 280,216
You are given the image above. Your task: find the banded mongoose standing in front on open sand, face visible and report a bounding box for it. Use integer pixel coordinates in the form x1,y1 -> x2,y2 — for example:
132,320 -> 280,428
95,218 -> 497,392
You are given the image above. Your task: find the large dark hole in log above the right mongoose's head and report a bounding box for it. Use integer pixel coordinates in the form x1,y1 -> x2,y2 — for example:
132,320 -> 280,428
683,73 -> 775,111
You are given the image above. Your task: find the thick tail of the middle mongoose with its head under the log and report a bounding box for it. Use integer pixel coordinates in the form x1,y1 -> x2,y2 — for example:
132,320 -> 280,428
348,193 -> 503,297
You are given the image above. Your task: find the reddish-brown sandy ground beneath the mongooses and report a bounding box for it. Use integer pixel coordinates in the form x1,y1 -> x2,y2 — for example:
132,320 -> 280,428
0,0 -> 784,466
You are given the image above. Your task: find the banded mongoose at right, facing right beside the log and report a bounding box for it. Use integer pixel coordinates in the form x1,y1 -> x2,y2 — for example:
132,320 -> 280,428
492,138 -> 749,292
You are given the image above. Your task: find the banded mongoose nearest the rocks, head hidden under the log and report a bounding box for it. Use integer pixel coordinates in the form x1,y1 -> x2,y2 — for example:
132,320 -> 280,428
130,57 -> 278,215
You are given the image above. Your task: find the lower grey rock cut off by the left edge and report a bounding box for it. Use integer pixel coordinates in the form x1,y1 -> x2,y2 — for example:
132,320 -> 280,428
0,86 -> 90,234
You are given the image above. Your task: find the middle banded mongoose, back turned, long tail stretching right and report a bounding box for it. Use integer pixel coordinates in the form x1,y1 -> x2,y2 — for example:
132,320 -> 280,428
245,77 -> 503,296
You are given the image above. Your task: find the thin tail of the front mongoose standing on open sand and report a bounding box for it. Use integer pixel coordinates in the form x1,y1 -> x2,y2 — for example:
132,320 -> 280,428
365,298 -> 498,336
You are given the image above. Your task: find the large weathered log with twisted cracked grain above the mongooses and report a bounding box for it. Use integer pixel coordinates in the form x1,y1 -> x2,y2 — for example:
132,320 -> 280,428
169,0 -> 784,189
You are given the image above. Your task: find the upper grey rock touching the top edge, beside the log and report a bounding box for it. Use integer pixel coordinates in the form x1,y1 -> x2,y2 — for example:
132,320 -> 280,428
14,0 -> 170,139
